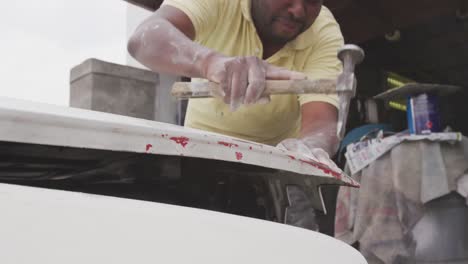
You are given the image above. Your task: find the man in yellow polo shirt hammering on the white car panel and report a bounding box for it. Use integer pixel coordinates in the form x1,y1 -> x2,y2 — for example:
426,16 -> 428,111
128,0 -> 343,164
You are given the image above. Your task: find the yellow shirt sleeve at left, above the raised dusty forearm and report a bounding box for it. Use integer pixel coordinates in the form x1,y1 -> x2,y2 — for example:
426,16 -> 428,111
162,0 -> 223,41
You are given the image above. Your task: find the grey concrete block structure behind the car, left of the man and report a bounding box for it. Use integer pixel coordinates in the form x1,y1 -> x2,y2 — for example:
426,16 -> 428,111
70,59 -> 159,120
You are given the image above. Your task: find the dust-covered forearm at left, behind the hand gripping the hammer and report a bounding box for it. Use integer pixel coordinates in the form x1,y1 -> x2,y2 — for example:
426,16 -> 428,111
128,18 -> 216,78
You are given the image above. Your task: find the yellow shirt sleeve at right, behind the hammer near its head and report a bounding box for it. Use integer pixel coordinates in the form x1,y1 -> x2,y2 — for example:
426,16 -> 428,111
298,10 -> 344,107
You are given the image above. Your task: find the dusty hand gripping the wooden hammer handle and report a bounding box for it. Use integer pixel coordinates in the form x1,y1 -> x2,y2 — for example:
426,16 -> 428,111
203,53 -> 306,111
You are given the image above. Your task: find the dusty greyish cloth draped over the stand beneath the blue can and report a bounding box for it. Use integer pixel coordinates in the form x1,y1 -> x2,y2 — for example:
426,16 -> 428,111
335,137 -> 468,264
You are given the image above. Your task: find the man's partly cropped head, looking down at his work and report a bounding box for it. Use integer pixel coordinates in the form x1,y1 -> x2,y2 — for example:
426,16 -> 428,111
251,0 -> 323,44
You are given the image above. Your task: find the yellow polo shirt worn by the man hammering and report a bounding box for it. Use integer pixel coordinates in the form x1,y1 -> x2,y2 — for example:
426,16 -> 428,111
163,0 -> 344,145
